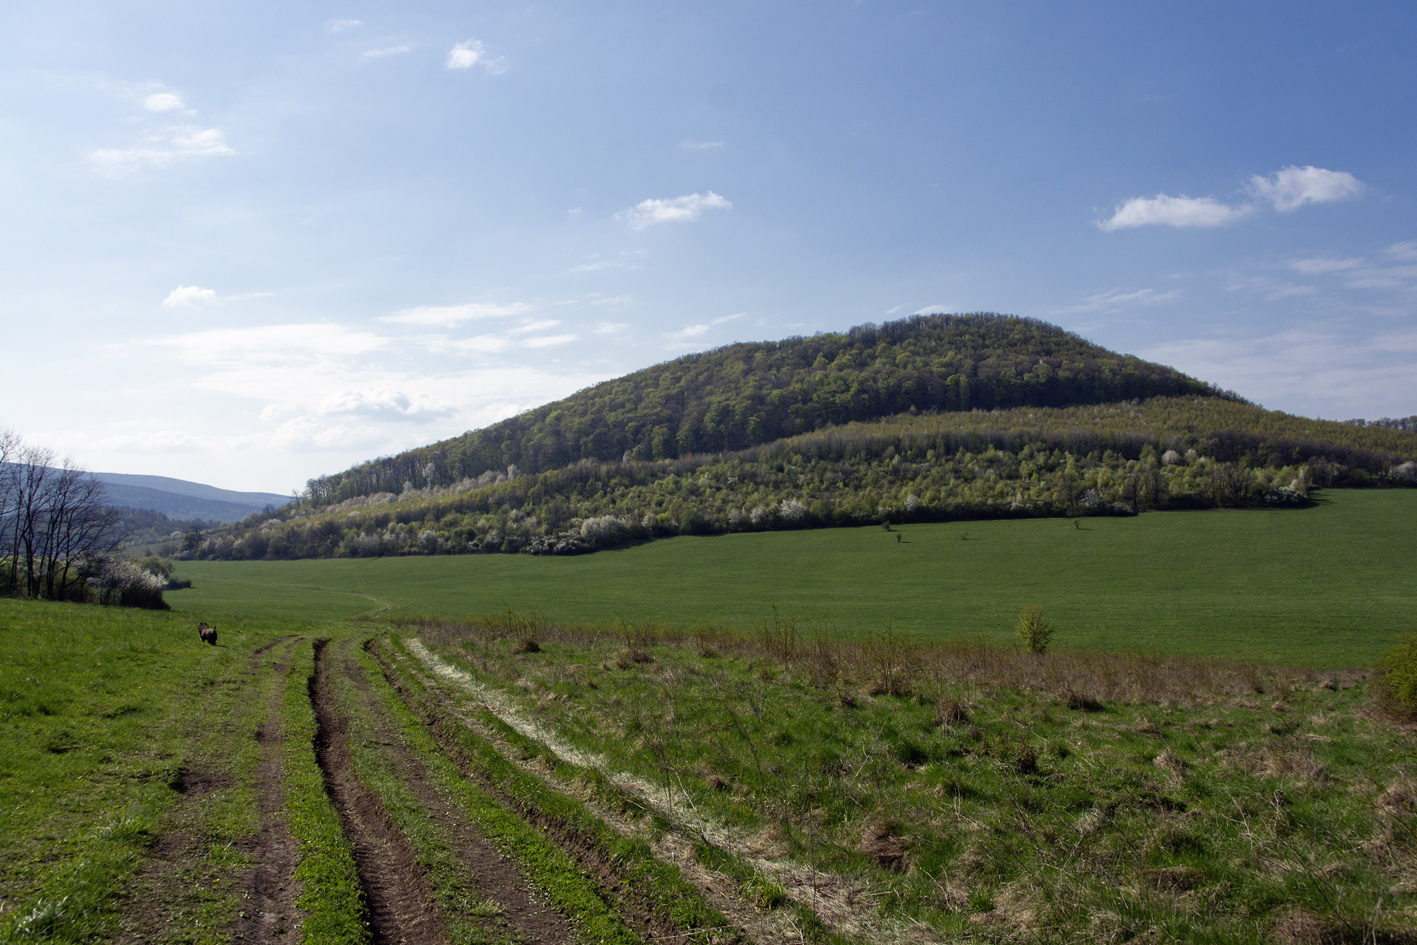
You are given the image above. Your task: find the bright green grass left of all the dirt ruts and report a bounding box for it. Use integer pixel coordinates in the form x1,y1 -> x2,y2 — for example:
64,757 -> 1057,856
0,601 -> 274,942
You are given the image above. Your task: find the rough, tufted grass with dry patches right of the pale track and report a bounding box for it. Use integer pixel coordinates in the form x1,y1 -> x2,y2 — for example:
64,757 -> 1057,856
405,621 -> 1417,942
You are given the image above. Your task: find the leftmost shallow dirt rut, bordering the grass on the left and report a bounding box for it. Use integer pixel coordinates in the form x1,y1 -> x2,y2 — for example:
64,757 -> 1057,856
231,636 -> 303,945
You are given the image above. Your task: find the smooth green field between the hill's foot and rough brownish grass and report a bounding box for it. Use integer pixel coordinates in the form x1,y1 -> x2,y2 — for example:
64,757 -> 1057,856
169,490 -> 1417,669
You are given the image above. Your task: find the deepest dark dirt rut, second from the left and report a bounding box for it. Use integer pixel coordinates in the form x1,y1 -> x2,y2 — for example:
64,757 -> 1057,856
310,638 -> 446,945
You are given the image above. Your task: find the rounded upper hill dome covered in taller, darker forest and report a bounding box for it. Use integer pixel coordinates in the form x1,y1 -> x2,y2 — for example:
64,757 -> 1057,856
307,315 -> 1236,507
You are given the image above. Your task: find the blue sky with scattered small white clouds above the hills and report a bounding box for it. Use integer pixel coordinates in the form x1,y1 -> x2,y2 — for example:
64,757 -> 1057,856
0,0 -> 1417,493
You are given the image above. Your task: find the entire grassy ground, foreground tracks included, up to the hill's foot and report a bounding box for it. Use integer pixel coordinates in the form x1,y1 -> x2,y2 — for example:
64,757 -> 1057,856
0,490 -> 1417,945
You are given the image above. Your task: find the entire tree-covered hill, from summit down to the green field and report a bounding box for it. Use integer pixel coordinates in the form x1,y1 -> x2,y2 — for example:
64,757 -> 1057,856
181,316 -> 1417,560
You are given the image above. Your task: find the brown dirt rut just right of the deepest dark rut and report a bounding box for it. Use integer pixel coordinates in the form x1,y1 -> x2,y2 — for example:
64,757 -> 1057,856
343,656 -> 577,944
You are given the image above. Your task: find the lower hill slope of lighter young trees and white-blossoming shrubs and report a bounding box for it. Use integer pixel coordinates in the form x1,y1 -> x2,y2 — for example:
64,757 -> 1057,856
184,395 -> 1417,560
